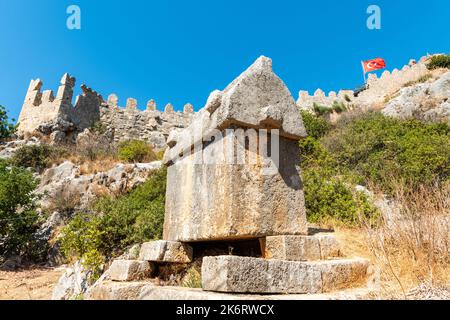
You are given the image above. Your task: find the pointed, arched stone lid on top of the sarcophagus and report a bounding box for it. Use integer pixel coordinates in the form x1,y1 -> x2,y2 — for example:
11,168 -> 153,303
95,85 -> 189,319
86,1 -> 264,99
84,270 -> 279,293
164,56 -> 306,161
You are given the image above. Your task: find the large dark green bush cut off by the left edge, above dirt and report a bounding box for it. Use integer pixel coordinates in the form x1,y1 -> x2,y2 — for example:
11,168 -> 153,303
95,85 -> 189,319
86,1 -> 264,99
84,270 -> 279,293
0,161 -> 46,261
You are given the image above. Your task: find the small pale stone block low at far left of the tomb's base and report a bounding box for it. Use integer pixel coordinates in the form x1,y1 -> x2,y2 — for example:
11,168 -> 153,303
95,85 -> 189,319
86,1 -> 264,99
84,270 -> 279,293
108,260 -> 154,281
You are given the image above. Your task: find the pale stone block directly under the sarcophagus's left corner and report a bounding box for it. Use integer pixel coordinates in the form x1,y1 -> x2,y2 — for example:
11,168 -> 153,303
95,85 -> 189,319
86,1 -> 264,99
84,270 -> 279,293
139,240 -> 193,263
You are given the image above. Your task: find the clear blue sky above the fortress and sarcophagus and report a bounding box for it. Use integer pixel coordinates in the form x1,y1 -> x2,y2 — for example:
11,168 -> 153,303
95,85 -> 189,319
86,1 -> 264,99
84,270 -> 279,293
0,0 -> 450,117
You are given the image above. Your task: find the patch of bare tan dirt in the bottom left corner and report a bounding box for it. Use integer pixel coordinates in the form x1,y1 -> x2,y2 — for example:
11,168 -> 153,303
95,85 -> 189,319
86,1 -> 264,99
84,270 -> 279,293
0,268 -> 64,300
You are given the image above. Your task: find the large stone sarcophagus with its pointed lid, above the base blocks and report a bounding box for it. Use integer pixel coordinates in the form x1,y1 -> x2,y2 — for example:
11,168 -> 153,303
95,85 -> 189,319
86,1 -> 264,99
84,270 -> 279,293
164,57 -> 307,242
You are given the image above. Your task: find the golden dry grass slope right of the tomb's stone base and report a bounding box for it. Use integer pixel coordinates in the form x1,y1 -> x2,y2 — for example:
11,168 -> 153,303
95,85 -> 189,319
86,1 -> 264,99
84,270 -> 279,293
322,184 -> 450,299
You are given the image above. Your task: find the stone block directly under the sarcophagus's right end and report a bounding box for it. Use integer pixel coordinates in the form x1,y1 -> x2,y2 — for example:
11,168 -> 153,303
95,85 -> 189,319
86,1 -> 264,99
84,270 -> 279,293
262,234 -> 340,261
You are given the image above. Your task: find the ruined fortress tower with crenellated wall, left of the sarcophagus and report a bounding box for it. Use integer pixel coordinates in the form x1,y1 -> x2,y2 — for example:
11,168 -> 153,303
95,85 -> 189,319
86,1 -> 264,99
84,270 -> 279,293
18,73 -> 194,148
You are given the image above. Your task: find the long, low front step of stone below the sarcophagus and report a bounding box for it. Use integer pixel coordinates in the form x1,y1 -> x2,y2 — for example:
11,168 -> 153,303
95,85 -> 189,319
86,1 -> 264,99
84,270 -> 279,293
202,256 -> 369,294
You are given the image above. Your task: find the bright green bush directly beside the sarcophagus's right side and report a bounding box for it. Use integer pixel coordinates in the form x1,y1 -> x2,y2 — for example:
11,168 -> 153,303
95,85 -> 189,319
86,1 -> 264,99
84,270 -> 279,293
300,112 -> 378,225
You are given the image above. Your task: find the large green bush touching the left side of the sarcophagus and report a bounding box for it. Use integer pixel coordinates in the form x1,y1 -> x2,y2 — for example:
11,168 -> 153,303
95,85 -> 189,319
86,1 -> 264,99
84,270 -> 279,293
61,168 -> 166,271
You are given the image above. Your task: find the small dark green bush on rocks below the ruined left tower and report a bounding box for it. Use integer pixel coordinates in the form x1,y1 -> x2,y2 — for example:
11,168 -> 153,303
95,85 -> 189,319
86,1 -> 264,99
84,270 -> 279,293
10,145 -> 52,171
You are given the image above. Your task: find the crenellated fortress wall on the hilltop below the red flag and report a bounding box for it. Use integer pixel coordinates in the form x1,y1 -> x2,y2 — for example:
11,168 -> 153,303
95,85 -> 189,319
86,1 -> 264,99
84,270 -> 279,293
297,56 -> 429,110
